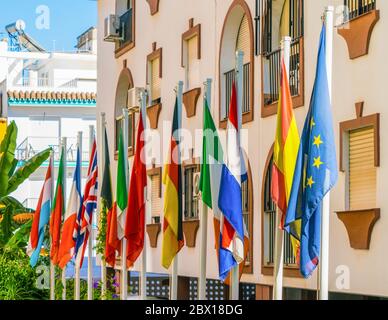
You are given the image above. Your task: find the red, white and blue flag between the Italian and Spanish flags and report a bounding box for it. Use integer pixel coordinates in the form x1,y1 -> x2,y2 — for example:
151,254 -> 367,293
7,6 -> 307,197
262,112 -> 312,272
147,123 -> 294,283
218,83 -> 246,280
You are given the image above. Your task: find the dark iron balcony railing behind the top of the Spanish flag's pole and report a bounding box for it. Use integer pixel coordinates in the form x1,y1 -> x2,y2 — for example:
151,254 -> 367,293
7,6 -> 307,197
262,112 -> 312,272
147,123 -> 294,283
264,38 -> 301,105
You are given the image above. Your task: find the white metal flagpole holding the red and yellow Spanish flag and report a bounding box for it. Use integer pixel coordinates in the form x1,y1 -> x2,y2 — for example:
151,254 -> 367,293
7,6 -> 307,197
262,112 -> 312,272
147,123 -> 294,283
272,37 -> 291,300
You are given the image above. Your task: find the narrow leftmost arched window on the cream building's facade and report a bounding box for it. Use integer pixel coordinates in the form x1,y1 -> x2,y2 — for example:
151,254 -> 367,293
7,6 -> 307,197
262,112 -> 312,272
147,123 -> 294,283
115,67 -> 135,156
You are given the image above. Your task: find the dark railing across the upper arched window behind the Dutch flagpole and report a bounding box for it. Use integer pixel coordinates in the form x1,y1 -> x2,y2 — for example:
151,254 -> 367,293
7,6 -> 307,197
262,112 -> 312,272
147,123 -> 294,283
224,62 -> 251,119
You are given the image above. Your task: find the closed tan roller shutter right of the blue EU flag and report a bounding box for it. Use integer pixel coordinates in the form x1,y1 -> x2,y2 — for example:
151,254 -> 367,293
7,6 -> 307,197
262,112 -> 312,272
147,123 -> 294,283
349,127 -> 376,210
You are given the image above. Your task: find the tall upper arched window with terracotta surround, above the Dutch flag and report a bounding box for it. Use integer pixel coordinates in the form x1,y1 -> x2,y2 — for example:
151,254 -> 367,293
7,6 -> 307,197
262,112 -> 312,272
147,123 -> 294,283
219,0 -> 254,128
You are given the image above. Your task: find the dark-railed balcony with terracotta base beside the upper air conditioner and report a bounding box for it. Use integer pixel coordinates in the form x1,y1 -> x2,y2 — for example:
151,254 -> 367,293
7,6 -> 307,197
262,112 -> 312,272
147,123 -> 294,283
115,8 -> 135,58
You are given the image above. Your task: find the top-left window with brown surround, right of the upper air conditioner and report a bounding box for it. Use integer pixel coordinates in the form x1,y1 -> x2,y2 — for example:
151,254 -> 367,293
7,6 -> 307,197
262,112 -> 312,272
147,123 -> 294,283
115,0 -> 135,58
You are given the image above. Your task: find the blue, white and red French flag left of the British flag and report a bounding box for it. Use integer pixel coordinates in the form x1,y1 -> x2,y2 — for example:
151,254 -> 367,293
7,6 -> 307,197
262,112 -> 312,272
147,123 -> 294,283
58,148 -> 82,269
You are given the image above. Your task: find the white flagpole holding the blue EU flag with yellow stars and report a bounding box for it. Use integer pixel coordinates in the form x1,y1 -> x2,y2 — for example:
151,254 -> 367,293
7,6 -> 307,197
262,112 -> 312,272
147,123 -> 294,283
319,6 -> 334,300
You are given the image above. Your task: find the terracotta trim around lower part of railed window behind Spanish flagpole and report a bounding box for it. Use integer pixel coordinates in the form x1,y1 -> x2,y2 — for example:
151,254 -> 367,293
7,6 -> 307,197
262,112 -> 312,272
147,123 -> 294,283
260,37 -> 304,118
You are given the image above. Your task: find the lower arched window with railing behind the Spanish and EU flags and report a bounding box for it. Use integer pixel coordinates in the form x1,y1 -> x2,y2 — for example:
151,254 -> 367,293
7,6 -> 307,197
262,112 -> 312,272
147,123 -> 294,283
262,148 -> 297,276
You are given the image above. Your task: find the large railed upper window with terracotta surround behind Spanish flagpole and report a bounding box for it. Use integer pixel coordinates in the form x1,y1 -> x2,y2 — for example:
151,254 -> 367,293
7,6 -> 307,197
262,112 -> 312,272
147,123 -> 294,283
262,0 -> 304,117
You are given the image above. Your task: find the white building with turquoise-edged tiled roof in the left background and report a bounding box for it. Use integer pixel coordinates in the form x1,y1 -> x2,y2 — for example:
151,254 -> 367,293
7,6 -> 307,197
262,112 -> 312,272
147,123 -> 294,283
0,22 -> 97,208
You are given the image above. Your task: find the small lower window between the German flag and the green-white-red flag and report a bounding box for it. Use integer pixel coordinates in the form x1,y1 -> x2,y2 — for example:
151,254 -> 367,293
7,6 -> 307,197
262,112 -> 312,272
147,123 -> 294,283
184,166 -> 199,220
